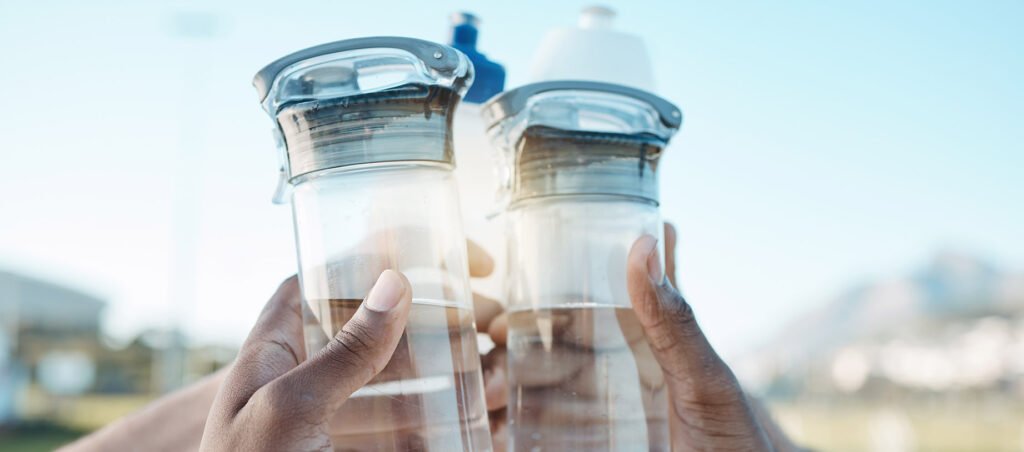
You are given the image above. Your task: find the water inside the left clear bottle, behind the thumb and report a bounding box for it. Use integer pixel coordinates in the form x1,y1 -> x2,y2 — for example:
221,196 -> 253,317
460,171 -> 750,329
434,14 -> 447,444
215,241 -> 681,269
303,298 -> 490,452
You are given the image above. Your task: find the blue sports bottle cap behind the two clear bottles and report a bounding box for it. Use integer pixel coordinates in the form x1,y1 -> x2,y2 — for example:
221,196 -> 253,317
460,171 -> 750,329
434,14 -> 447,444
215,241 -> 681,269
450,12 -> 505,104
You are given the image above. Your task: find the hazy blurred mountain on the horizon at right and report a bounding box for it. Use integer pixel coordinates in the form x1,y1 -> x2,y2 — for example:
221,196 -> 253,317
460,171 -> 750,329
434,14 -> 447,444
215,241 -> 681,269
737,252 -> 1024,393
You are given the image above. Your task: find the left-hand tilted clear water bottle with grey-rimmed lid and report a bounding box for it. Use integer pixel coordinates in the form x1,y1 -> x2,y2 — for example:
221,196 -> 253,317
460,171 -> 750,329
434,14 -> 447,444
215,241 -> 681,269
253,38 -> 490,451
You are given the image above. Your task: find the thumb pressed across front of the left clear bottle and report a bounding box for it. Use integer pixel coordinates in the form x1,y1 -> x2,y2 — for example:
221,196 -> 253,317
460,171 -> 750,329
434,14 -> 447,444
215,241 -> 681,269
265,270 -> 413,413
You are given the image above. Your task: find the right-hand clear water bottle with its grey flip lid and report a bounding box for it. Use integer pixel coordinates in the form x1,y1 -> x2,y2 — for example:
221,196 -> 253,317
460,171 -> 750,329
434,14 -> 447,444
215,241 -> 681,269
483,81 -> 682,451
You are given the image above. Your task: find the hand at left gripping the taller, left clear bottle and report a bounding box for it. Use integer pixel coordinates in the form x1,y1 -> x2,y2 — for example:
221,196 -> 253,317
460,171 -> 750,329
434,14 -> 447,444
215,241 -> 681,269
201,271 -> 412,451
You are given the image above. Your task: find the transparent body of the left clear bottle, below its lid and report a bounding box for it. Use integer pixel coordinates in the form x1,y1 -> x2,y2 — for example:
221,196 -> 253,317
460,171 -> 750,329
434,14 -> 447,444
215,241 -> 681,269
292,163 -> 490,451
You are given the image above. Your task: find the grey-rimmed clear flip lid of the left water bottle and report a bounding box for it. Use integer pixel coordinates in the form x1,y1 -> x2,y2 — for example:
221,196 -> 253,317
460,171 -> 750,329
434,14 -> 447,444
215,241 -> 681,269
253,37 -> 473,198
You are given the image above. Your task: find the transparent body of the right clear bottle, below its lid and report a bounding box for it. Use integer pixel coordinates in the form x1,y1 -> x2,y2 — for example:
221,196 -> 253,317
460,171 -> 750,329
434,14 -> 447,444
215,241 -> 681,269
507,196 -> 670,451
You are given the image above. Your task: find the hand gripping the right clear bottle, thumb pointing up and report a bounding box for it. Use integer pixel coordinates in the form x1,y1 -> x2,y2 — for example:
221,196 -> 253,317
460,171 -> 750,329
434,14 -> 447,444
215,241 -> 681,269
483,224 -> 800,451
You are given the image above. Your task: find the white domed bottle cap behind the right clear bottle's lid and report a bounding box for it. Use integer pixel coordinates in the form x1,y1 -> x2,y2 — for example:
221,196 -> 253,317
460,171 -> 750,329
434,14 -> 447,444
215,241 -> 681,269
530,6 -> 655,91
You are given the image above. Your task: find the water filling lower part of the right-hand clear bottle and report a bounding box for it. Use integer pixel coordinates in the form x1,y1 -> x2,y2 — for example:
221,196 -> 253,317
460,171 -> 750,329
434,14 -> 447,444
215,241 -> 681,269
508,305 -> 670,451
